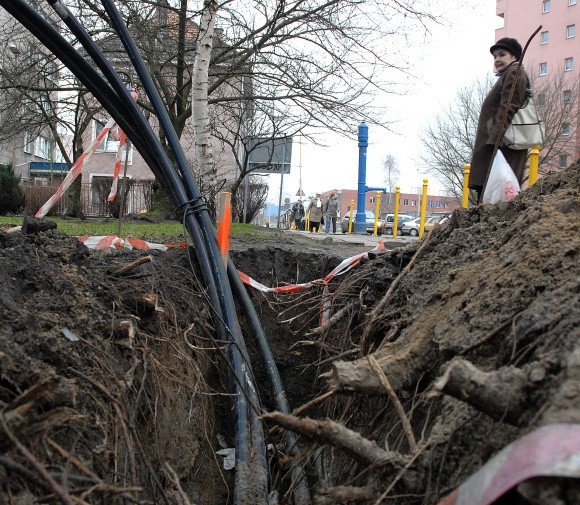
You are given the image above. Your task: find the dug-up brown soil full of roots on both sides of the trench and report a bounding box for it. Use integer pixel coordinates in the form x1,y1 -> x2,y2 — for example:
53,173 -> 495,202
0,166 -> 580,505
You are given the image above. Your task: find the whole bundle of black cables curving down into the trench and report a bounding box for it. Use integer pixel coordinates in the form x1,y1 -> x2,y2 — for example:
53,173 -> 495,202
0,0 -> 310,504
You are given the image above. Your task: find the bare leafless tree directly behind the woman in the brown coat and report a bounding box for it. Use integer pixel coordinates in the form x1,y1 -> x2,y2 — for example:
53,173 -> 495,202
420,71 -> 580,199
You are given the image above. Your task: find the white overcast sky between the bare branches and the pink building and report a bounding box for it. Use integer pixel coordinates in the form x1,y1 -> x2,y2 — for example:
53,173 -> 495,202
268,0 -> 501,204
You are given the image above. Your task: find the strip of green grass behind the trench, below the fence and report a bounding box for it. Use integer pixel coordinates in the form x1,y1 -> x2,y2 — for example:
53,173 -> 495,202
0,216 -> 280,243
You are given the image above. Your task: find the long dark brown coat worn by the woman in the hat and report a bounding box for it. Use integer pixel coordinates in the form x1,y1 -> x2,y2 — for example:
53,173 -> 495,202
469,62 -> 529,191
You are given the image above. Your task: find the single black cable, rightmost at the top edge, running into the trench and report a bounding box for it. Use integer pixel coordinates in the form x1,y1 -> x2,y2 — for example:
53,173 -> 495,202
101,0 -> 267,503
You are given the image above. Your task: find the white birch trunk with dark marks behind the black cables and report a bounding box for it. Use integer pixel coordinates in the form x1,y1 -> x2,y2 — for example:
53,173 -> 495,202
191,0 -> 218,191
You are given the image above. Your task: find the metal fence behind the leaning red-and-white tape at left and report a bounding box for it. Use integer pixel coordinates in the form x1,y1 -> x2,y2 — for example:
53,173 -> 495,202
22,178 -> 154,217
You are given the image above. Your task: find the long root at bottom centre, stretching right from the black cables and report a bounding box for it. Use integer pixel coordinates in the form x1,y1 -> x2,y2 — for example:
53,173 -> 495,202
262,412 -> 407,470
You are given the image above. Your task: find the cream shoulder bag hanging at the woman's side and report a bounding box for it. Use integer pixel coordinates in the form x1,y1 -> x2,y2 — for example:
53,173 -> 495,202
503,88 -> 545,150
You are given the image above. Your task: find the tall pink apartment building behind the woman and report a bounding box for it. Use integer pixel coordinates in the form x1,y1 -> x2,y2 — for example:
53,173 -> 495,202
496,0 -> 580,172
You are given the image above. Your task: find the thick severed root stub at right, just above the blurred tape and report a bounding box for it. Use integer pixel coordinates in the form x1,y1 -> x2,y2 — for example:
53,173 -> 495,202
434,358 -> 530,425
